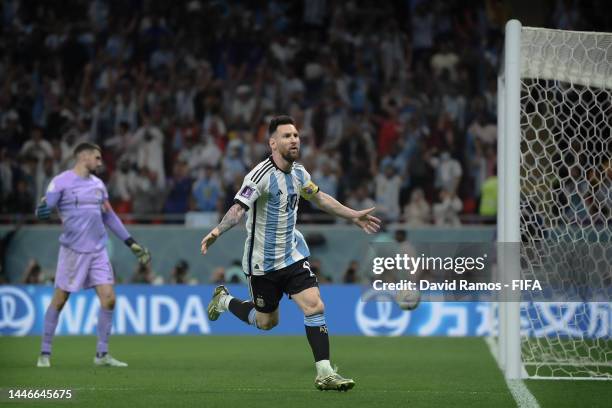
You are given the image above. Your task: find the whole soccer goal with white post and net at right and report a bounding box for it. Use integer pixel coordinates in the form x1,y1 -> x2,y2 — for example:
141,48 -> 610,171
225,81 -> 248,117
498,20 -> 612,380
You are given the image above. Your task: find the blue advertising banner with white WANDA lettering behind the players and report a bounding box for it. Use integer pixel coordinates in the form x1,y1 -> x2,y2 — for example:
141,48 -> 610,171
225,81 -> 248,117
0,285 -> 612,338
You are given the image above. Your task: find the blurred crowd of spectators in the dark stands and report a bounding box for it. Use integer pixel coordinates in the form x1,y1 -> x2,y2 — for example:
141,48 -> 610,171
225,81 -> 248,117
0,0 -> 604,225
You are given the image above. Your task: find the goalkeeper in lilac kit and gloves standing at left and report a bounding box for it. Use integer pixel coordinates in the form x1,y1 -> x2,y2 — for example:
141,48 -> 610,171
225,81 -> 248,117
36,143 -> 151,367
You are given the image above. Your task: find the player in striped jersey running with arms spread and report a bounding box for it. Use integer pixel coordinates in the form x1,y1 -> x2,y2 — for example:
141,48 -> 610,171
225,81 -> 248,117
201,116 -> 380,391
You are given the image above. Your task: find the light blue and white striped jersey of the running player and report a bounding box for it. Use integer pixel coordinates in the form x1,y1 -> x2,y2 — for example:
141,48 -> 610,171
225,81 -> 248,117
234,156 -> 319,275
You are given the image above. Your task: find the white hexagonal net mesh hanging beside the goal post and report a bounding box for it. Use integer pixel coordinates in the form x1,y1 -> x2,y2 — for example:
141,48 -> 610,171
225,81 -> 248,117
520,28 -> 612,379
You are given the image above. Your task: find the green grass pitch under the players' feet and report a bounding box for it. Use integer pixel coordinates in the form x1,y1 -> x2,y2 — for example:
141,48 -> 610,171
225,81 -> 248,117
0,336 -> 612,408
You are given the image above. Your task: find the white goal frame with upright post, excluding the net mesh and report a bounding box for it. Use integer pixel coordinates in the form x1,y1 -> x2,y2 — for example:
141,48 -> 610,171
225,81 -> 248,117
498,20 -> 612,380
